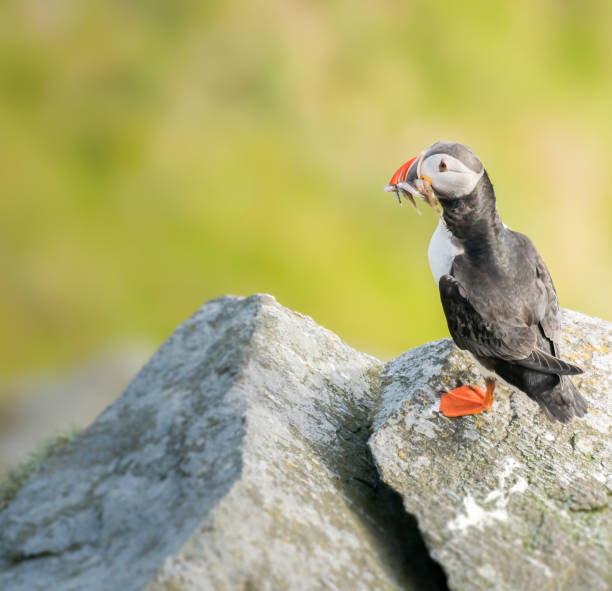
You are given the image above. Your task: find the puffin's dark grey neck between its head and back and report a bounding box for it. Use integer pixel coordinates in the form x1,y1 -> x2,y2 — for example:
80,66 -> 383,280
439,171 -> 505,262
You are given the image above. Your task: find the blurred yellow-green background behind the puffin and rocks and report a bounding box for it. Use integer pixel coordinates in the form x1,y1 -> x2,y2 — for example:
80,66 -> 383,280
0,0 -> 612,386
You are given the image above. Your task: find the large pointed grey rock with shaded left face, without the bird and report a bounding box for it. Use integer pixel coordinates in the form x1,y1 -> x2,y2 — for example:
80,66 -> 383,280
0,296 -> 444,591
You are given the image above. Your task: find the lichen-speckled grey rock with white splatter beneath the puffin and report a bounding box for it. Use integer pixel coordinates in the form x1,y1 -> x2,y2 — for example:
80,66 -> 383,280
369,312 -> 612,591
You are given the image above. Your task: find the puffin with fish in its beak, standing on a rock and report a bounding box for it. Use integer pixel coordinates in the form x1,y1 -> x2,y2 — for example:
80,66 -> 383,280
385,142 -> 587,423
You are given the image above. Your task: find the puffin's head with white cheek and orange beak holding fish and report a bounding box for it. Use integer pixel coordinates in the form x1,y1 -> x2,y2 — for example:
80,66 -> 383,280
385,142 -> 485,205
